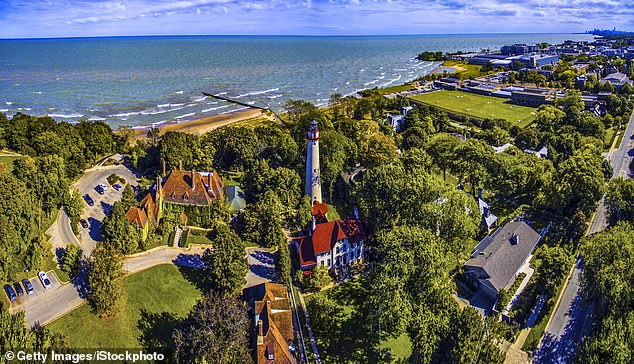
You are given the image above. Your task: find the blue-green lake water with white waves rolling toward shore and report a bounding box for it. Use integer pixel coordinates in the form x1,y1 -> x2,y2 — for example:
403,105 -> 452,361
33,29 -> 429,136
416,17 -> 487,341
0,34 -> 592,127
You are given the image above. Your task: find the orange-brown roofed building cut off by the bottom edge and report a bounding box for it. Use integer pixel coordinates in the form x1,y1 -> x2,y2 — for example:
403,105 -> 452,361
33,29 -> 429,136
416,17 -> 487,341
242,282 -> 297,364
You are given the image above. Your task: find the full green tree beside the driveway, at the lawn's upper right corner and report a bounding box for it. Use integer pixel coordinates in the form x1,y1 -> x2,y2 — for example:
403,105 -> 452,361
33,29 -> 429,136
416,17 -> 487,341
202,222 -> 249,296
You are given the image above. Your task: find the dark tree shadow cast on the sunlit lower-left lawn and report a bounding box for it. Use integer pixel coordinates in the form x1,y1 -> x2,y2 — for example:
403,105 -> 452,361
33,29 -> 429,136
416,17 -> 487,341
137,309 -> 180,357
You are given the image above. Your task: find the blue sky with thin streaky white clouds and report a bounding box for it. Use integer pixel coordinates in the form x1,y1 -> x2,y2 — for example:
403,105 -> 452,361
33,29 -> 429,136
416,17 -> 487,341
0,0 -> 634,38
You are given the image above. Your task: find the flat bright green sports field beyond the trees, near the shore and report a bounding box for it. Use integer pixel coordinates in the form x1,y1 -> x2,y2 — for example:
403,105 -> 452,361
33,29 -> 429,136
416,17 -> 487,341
411,90 -> 535,128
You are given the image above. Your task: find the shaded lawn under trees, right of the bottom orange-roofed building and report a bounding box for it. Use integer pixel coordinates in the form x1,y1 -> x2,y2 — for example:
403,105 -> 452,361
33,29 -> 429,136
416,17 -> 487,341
304,278 -> 411,363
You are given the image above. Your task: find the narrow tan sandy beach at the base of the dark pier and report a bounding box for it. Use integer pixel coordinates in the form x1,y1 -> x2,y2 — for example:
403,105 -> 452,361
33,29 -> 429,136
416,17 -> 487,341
134,110 -> 272,139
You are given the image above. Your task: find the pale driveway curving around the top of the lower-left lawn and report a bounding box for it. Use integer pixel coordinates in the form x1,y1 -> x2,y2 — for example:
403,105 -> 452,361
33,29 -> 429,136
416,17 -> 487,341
10,245 -> 208,328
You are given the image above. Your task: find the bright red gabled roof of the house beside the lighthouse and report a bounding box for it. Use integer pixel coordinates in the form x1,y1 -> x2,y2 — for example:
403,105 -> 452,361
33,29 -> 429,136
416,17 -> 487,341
312,217 -> 364,254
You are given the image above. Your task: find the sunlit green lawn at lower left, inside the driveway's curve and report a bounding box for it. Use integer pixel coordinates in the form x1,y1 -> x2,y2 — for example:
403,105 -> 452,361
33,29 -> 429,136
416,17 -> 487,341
47,264 -> 202,348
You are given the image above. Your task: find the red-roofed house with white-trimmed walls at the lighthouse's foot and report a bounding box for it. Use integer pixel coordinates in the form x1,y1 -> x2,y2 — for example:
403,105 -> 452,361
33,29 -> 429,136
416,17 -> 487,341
293,217 -> 365,269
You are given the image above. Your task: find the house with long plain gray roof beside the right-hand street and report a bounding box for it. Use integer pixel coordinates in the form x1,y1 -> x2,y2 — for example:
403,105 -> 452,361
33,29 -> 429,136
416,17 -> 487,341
464,221 -> 541,310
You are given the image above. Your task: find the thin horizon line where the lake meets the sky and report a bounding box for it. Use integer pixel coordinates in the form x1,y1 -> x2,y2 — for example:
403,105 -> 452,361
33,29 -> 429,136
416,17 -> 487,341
0,32 -> 593,40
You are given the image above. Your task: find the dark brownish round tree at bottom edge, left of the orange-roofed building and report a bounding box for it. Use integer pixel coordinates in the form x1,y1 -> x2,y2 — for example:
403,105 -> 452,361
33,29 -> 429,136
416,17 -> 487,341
173,292 -> 253,364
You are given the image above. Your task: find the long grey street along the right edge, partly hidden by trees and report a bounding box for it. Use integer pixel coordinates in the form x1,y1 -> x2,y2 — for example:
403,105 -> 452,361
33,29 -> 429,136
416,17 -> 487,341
535,109 -> 634,363
